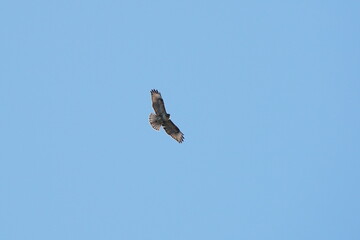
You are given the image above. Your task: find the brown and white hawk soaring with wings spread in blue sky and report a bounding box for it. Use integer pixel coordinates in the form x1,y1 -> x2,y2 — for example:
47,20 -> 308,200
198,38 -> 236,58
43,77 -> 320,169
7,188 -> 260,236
149,89 -> 184,143
